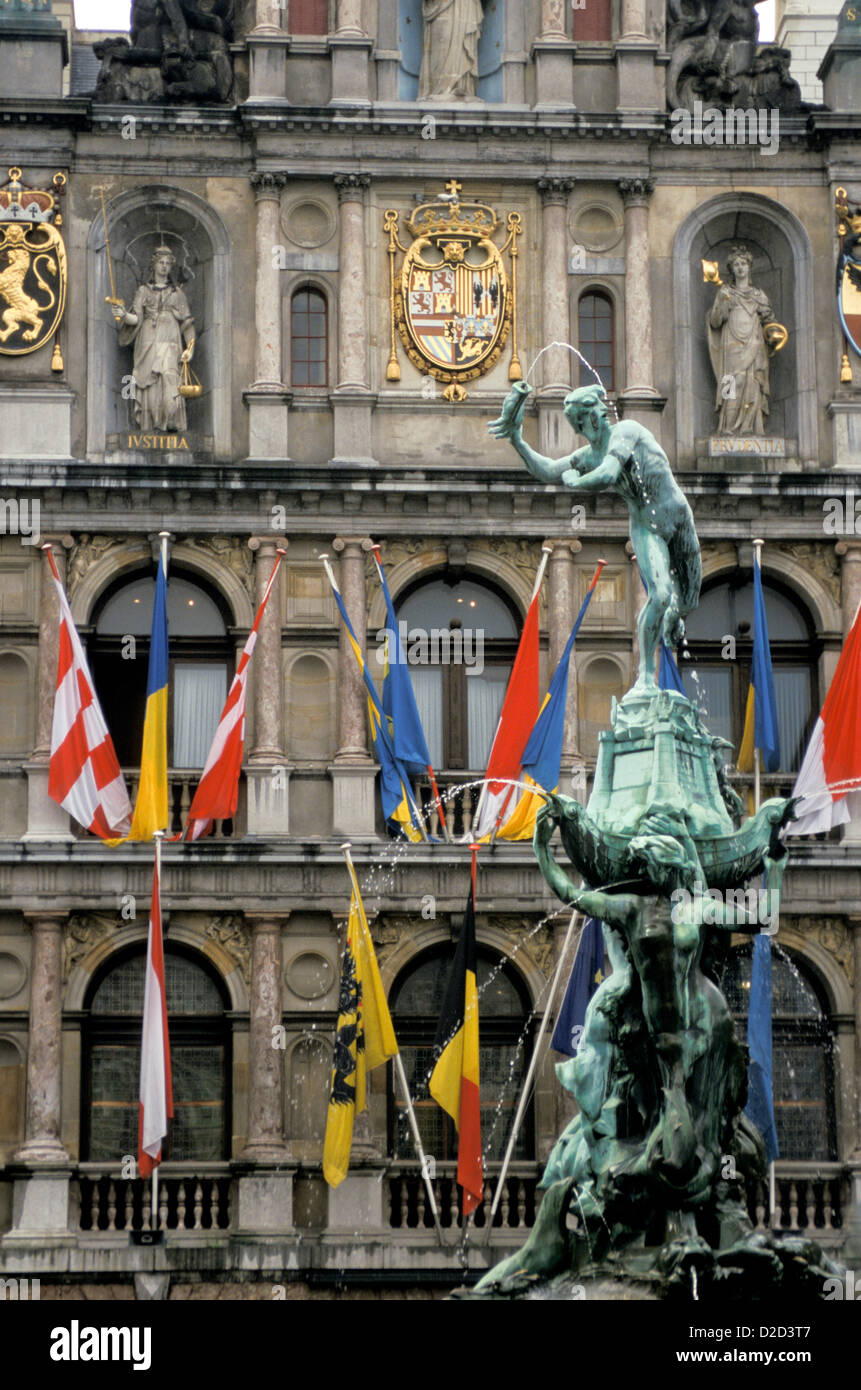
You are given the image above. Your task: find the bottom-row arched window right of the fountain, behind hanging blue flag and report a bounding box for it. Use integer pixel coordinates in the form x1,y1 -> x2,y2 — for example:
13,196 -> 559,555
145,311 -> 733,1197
722,941 -> 837,1159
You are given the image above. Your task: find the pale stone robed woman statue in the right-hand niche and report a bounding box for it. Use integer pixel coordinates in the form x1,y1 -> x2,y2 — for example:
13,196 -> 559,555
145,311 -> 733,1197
707,246 -> 776,435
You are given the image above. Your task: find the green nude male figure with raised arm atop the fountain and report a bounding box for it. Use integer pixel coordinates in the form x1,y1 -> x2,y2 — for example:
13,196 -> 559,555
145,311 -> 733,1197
488,381 -> 702,691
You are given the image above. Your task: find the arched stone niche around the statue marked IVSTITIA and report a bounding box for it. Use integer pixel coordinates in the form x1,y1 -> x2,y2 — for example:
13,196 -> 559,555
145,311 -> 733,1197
86,183 -> 231,459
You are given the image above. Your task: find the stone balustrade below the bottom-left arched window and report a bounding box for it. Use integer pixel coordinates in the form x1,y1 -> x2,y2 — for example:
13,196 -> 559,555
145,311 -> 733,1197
72,1163 -> 232,1236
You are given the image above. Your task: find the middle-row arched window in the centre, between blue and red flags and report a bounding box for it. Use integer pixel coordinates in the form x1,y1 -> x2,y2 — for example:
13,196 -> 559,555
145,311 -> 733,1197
398,578 -> 520,771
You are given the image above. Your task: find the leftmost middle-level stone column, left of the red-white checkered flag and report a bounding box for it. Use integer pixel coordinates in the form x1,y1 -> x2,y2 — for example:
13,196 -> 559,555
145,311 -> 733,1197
22,534 -> 74,841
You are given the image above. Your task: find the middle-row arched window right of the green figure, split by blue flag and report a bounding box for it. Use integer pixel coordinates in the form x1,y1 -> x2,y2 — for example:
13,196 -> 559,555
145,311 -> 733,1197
682,574 -> 822,773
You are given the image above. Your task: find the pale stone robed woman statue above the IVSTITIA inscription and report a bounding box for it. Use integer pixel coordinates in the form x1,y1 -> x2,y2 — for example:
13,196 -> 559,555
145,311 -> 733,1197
114,246 -> 195,434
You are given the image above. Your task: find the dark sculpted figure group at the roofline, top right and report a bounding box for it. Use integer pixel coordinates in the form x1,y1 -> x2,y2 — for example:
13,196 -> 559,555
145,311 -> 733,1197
666,0 -> 804,114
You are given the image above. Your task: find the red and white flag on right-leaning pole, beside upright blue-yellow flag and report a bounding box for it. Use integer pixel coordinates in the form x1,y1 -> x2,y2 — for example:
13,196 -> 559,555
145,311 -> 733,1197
185,550 -> 287,840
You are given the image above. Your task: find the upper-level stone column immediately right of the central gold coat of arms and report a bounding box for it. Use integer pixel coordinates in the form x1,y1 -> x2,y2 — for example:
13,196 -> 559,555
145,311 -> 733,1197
537,178 -> 576,457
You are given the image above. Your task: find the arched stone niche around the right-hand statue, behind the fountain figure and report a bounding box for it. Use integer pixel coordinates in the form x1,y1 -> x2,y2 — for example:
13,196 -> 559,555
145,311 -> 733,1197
673,193 -> 818,467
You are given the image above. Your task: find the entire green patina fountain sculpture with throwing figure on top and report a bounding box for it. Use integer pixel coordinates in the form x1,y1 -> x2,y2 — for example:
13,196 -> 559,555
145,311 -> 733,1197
467,384 -> 835,1298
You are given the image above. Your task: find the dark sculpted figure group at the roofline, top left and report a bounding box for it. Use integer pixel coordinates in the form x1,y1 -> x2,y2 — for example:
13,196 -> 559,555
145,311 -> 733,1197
93,0 -> 234,104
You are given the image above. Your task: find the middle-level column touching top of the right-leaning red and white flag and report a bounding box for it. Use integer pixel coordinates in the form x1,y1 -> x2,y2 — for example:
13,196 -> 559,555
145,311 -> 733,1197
245,535 -> 292,838
